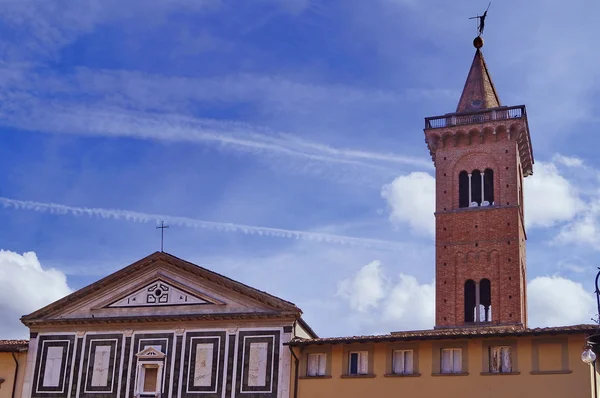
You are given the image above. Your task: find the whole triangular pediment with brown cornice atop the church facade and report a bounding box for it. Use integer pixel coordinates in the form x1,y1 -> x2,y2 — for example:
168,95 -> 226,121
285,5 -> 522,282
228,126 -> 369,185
21,252 -> 301,326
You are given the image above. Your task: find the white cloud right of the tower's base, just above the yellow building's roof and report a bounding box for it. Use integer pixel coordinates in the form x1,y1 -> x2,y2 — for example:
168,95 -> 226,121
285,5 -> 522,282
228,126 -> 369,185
527,276 -> 597,327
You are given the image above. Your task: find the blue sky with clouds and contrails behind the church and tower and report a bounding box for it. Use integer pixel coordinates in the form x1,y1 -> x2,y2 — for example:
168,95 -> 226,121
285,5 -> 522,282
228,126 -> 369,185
0,0 -> 600,338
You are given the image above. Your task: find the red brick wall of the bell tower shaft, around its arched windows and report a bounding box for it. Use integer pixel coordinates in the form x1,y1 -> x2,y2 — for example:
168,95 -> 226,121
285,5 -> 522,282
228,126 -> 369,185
425,120 -> 526,327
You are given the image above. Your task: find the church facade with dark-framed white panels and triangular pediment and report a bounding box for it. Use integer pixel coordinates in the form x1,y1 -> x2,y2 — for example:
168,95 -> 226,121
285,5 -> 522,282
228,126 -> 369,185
13,252 -> 316,398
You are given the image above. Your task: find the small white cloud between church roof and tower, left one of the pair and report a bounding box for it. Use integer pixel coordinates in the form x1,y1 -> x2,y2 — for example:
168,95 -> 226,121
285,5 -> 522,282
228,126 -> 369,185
338,261 -> 387,312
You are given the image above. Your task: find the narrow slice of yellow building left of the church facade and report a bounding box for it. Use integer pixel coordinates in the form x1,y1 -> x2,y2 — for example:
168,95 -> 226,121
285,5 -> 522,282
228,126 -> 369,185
0,340 -> 29,398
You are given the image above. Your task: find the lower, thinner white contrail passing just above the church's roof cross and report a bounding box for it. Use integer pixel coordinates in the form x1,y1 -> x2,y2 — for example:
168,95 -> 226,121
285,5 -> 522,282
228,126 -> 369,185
0,197 -> 403,251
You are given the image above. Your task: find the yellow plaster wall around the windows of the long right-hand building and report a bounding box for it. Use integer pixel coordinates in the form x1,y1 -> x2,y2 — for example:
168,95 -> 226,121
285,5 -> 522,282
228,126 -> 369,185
292,336 -> 591,398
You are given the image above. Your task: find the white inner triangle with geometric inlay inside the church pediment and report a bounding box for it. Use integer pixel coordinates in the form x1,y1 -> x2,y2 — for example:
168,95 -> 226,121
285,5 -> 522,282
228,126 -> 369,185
104,276 -> 224,308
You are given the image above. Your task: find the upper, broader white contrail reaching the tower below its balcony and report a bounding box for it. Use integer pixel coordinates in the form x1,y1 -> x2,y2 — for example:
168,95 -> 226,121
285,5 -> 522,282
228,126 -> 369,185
0,92 -> 433,174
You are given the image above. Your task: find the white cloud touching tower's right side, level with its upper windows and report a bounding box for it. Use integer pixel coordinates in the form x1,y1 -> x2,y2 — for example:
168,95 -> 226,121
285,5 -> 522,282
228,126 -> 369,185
524,162 -> 582,227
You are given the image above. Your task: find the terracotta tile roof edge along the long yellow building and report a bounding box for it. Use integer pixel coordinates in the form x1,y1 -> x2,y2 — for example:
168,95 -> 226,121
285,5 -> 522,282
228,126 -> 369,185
289,325 -> 599,346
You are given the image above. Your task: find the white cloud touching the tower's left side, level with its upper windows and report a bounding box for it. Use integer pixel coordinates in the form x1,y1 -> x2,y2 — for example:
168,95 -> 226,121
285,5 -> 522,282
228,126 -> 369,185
381,172 -> 435,236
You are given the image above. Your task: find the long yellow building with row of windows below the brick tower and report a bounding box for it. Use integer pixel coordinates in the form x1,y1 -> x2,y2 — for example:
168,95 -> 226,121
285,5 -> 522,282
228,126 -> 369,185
290,325 -> 597,398
